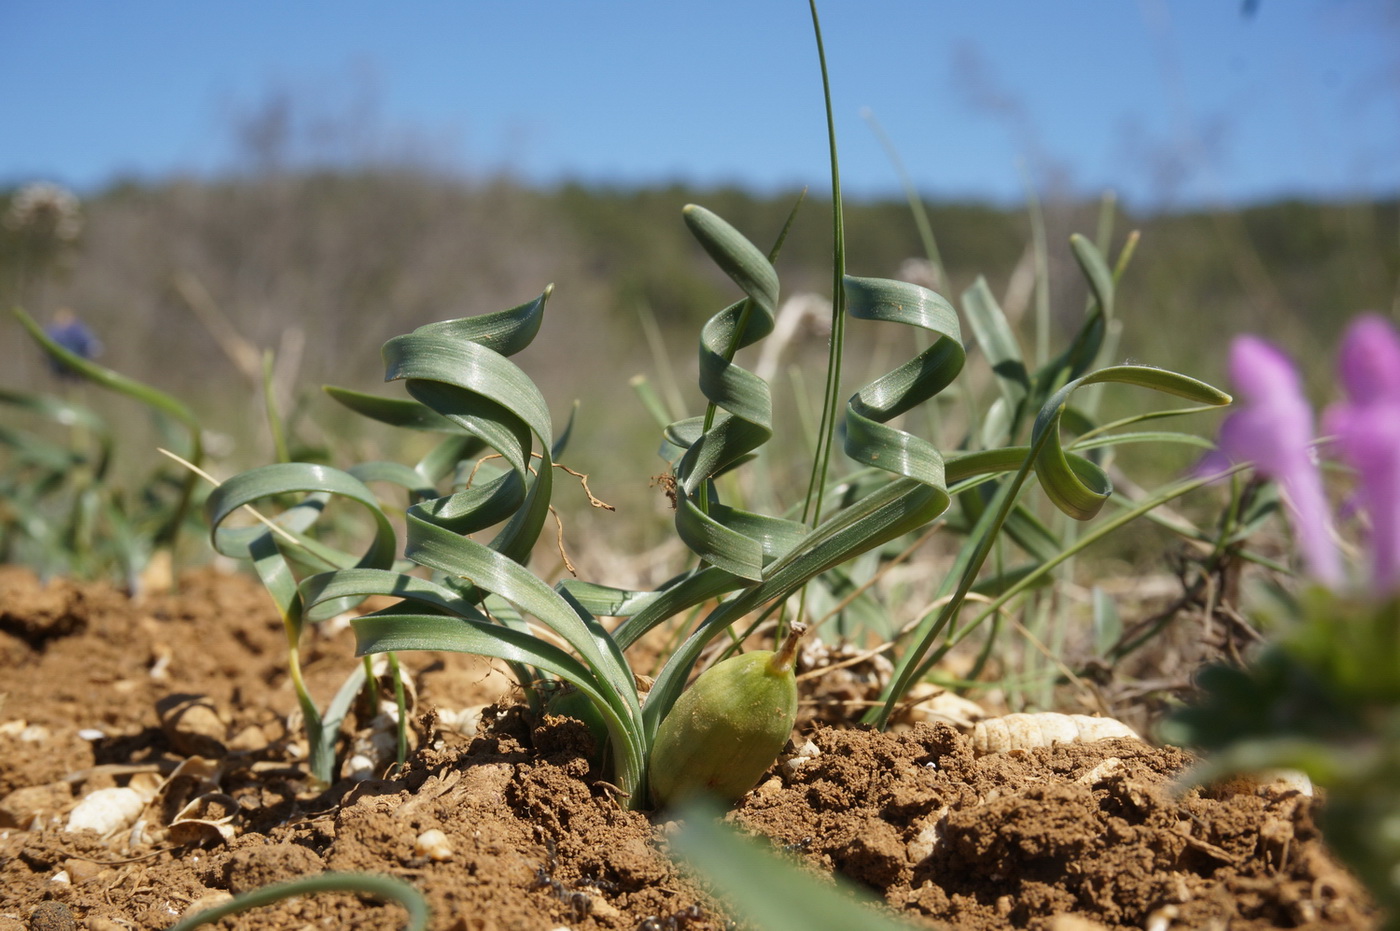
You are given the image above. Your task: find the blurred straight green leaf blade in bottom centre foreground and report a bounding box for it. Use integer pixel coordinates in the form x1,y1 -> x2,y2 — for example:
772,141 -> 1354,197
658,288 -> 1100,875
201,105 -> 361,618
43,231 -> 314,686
671,806 -> 914,931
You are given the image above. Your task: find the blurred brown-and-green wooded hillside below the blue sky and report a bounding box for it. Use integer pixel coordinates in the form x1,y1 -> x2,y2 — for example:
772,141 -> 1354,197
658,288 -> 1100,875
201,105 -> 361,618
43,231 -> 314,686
0,171 -> 1400,425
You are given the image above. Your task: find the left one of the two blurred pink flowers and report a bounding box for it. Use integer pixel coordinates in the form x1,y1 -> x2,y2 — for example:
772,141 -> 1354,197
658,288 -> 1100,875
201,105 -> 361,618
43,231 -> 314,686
1219,336 -> 1338,587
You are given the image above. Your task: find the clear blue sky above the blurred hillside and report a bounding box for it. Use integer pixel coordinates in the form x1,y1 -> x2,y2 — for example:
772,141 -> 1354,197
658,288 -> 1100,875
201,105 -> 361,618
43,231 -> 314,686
0,0 -> 1400,206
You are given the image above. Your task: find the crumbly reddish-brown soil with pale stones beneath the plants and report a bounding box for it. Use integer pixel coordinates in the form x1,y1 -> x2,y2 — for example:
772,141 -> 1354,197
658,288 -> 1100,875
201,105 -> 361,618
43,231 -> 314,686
0,568 -> 1376,931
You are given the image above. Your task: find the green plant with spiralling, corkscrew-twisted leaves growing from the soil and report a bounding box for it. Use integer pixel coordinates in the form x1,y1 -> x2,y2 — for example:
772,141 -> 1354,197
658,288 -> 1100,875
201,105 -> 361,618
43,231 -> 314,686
207,194 -> 1228,806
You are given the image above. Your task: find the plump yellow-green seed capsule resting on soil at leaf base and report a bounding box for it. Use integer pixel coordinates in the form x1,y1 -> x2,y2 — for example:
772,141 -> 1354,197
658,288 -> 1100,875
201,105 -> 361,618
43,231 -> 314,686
650,624 -> 805,805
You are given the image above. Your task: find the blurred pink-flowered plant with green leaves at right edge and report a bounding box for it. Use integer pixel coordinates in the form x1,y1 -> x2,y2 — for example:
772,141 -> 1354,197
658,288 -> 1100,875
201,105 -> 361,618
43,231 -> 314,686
1166,315 -> 1400,928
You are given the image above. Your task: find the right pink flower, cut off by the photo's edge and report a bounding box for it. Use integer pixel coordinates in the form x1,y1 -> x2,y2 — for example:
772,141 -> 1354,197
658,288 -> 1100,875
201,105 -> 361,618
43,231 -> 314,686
1324,314 -> 1400,592
